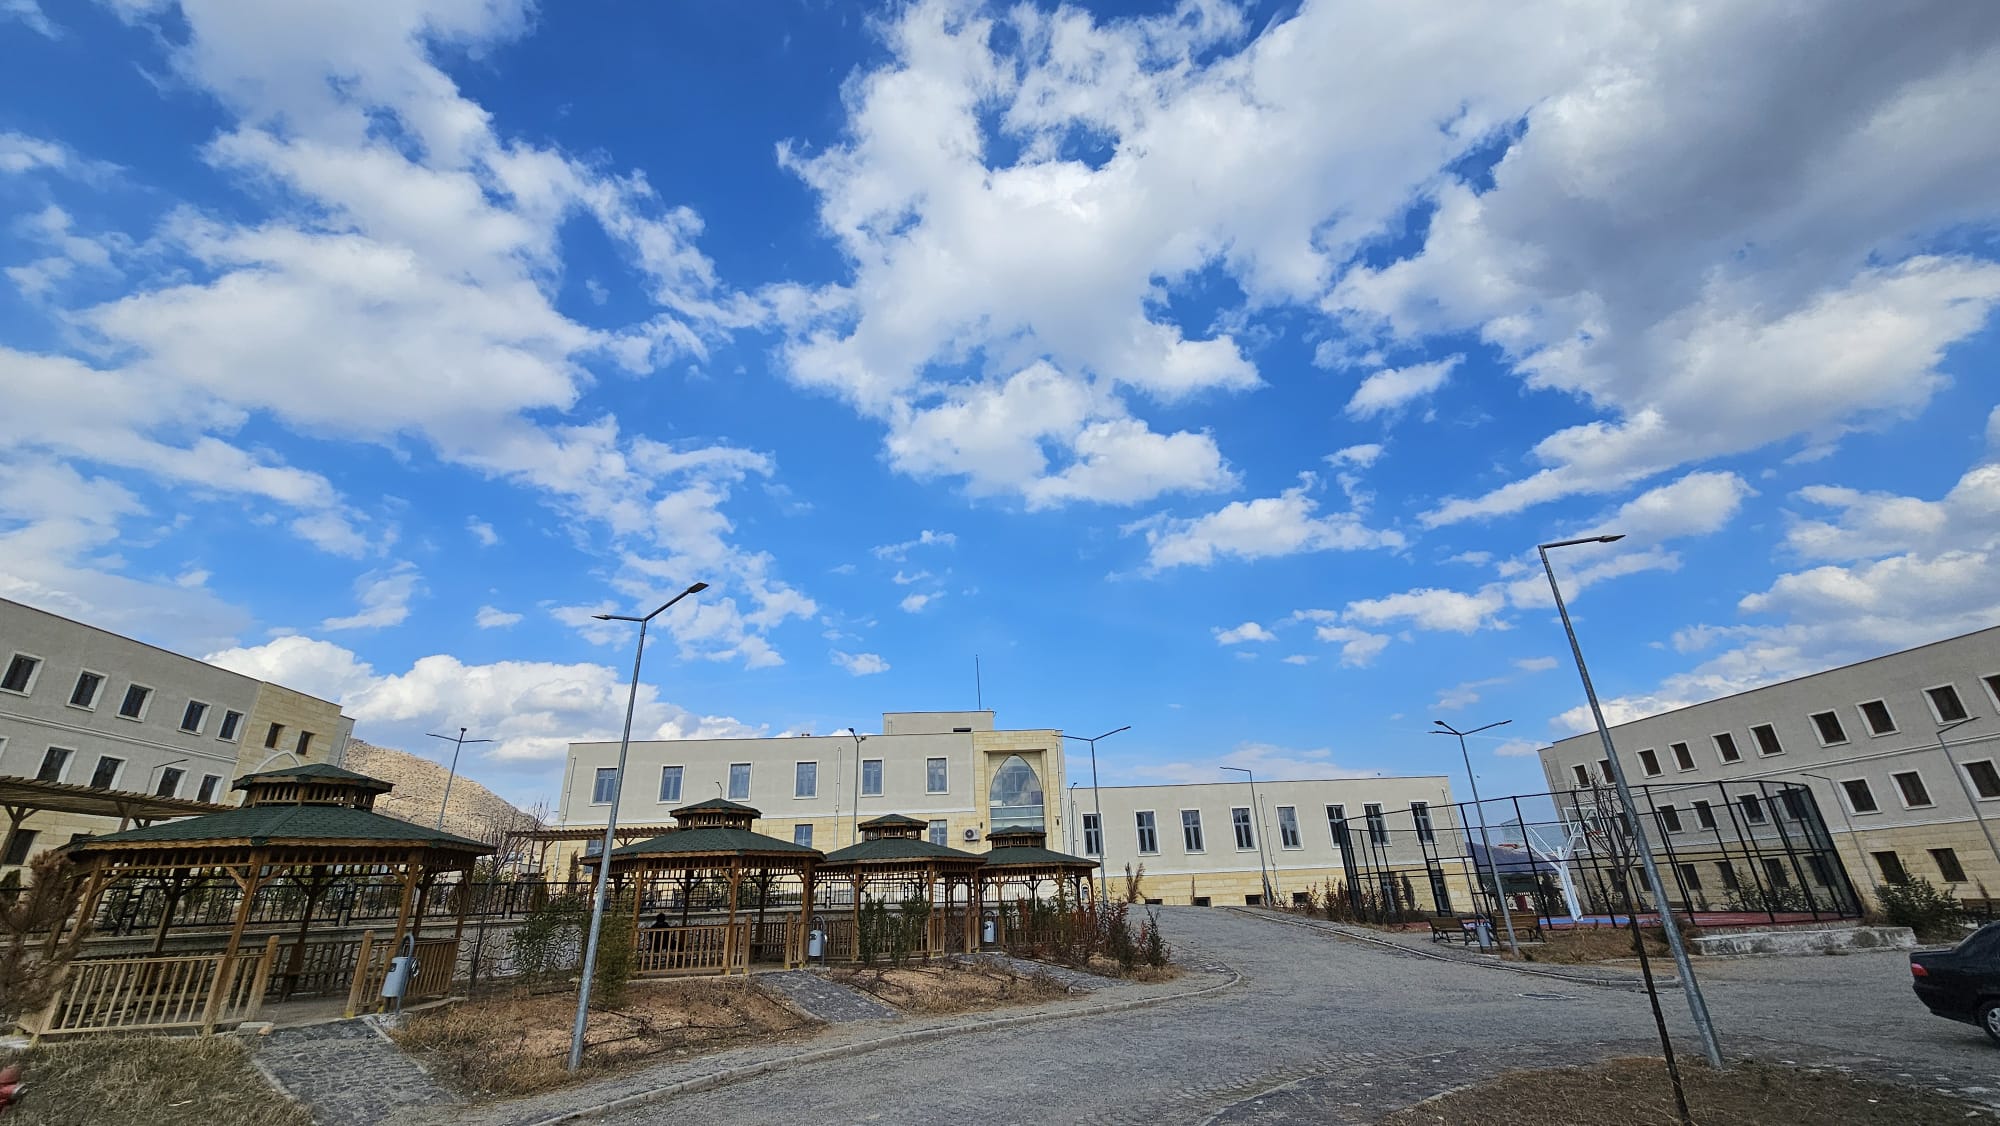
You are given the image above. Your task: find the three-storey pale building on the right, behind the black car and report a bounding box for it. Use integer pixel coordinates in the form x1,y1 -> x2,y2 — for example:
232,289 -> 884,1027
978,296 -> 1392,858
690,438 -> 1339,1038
1540,626 -> 2000,898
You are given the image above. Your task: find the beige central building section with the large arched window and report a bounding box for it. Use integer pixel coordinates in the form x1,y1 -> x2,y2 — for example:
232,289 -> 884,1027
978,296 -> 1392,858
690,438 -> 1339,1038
550,712 -> 1064,878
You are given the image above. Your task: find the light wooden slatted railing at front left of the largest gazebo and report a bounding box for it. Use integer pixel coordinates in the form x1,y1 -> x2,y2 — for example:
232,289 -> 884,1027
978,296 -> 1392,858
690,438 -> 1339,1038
22,938 -> 278,1038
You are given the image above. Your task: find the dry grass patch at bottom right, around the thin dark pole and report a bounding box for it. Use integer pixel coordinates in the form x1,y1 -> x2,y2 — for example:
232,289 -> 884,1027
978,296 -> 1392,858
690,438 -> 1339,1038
1378,1060 -> 1992,1126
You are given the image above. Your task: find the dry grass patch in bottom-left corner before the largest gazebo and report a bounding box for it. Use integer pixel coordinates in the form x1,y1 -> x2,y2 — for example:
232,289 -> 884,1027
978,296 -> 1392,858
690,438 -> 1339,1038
0,1036 -> 312,1126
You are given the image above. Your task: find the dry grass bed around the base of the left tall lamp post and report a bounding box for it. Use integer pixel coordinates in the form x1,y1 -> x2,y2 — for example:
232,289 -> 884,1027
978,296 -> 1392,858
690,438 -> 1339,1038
390,978 -> 818,1098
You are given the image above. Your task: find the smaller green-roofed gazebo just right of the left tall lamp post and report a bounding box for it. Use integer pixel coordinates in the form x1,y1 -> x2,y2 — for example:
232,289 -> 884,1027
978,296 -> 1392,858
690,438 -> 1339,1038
584,798 -> 824,974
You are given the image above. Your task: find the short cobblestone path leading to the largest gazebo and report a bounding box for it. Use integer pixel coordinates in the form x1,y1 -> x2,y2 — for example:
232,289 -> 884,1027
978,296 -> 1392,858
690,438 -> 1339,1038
256,1020 -> 454,1126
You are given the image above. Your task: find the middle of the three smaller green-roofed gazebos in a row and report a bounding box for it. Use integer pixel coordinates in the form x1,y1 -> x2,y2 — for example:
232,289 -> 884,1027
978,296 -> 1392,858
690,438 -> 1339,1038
818,814 -> 986,960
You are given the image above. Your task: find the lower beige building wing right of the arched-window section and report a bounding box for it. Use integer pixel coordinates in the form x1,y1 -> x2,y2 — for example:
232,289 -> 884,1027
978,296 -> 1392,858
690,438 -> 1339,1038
1050,776 -> 1470,910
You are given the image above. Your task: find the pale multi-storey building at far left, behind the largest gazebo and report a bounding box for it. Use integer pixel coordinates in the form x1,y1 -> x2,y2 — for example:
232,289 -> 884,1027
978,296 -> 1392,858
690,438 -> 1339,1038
0,598 -> 354,870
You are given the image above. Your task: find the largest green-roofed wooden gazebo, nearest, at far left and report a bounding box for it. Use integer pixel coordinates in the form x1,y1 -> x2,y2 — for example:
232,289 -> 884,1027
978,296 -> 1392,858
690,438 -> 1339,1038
43,764 -> 492,1036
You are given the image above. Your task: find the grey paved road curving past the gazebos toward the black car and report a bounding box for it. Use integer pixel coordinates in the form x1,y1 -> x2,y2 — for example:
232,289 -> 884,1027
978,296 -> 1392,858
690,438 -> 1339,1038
576,908 -> 2000,1126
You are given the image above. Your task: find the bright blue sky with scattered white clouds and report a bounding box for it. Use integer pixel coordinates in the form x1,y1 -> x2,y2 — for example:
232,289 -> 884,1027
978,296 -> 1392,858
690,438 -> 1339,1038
0,0 -> 2000,812
